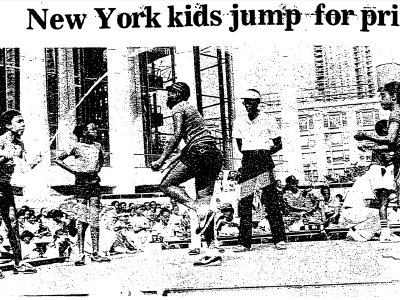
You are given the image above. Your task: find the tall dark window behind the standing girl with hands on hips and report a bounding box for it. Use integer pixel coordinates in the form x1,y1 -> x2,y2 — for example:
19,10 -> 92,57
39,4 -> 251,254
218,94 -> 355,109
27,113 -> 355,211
45,48 -> 110,165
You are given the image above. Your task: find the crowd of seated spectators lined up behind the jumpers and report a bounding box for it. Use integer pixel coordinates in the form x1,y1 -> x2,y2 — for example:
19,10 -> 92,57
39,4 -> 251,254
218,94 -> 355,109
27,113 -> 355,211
0,172 -> 398,263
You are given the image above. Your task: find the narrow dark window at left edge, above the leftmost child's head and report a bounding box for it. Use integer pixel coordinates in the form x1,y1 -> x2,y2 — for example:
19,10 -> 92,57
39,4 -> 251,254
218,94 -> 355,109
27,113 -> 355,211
0,48 -> 20,113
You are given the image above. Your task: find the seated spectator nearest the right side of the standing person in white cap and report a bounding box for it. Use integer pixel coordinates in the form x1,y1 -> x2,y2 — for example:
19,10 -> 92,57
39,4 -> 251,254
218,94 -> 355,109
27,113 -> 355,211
283,175 -> 322,231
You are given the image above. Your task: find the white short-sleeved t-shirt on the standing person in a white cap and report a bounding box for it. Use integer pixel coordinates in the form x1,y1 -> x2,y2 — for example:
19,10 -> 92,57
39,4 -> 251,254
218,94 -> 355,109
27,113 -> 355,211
233,112 -> 281,151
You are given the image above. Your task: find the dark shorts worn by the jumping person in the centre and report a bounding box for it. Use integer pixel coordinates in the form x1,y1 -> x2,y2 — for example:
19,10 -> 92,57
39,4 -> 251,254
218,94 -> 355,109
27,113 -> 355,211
180,143 -> 222,187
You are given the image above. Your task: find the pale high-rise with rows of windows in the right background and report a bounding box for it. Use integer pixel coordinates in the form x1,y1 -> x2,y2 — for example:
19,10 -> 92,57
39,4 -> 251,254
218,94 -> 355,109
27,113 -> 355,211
298,45 -> 380,184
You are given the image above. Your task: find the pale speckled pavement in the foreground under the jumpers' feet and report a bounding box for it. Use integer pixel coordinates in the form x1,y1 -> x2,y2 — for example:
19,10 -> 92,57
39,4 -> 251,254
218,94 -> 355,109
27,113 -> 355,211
0,240 -> 400,299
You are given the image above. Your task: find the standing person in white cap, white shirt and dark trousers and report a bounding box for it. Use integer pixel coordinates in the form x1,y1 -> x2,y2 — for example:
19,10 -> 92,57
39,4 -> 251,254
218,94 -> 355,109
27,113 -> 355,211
233,89 -> 286,252
